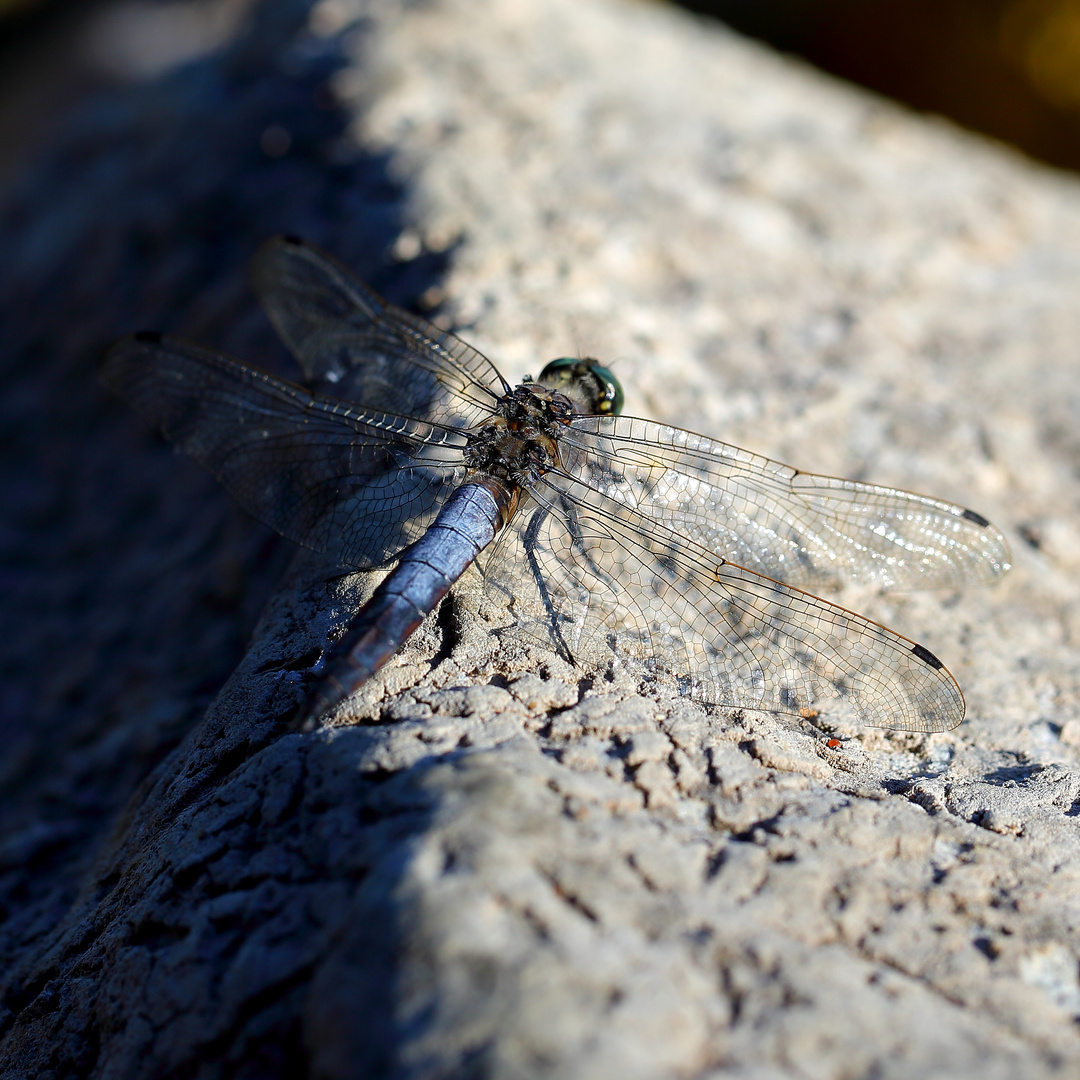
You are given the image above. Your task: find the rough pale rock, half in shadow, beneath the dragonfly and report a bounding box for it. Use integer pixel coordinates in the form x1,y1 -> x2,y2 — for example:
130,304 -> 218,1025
0,0 -> 1080,1080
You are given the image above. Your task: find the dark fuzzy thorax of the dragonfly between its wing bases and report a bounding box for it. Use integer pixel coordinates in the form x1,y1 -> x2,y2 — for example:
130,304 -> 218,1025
464,382 -> 573,487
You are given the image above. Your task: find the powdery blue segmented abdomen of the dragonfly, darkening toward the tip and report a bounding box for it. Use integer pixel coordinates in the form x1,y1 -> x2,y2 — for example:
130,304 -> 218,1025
310,478 -> 516,717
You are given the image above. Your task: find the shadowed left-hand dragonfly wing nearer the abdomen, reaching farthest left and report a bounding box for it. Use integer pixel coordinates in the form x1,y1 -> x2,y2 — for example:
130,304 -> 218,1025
102,334 -> 464,568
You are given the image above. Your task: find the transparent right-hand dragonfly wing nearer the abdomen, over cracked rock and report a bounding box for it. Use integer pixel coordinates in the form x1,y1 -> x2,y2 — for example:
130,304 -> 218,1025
484,473 -> 963,731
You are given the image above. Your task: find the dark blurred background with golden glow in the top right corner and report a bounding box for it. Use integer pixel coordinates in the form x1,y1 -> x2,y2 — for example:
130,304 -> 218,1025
684,0 -> 1080,170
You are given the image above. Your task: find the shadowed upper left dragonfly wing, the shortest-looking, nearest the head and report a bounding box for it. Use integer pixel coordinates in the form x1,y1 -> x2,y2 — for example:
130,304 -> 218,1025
252,237 -> 510,428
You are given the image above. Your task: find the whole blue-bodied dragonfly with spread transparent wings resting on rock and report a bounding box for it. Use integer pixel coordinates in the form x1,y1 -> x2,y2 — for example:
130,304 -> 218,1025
100,237 -> 1010,732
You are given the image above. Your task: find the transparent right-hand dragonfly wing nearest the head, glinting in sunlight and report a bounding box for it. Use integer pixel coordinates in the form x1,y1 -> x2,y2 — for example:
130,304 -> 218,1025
559,416 -> 1010,589
